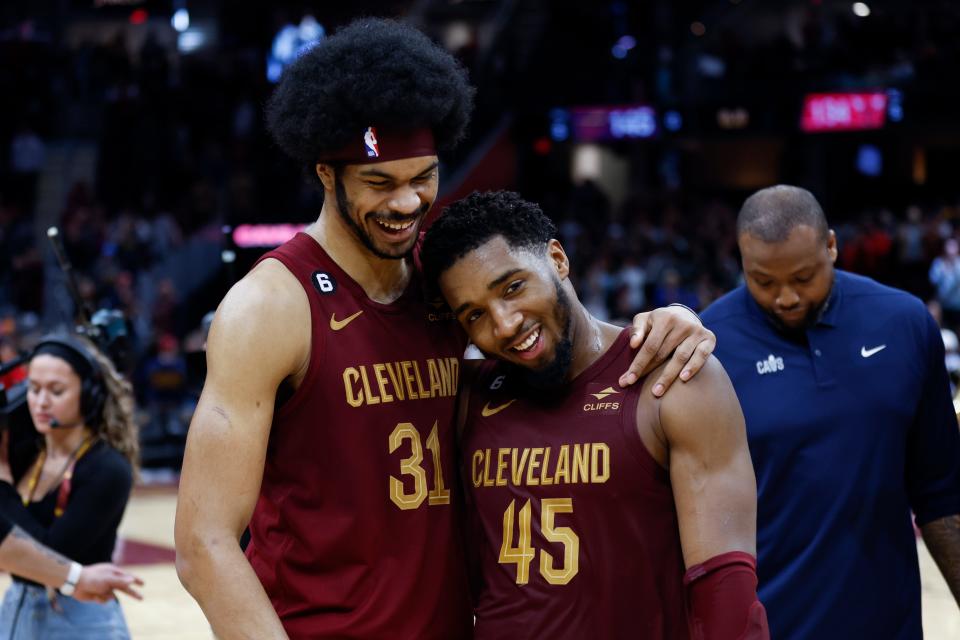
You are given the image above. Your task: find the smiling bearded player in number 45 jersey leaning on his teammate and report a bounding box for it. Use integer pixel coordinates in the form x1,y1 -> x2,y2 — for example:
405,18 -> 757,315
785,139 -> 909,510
422,192 -> 768,640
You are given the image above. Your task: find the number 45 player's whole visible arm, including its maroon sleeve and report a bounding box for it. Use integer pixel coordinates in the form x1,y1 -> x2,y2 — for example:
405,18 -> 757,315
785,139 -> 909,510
660,358 -> 770,640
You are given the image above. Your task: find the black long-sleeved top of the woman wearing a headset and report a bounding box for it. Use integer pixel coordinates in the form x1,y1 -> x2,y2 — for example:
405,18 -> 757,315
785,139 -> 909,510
0,441 -> 133,576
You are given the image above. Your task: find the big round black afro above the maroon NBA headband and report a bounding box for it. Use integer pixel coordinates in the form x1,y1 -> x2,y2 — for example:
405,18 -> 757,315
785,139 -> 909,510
266,19 -> 474,167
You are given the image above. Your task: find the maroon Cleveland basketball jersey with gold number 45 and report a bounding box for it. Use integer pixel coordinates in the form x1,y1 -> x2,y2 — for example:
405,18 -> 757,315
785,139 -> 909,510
462,331 -> 688,640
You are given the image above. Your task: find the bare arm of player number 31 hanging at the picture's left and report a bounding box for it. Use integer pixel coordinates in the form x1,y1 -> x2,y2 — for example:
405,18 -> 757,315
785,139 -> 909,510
175,261 -> 310,640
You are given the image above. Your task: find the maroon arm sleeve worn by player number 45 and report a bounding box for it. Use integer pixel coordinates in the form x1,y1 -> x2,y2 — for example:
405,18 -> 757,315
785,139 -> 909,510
683,551 -> 770,640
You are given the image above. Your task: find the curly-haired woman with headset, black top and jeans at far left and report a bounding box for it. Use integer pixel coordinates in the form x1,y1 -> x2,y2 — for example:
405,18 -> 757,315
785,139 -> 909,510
0,335 -> 139,640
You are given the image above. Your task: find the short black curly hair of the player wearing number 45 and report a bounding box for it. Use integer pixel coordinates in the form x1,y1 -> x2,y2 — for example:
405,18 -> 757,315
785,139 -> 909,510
420,191 -> 557,289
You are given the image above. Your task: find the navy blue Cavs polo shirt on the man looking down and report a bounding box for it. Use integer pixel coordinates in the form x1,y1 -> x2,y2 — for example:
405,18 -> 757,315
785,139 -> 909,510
703,271 -> 960,640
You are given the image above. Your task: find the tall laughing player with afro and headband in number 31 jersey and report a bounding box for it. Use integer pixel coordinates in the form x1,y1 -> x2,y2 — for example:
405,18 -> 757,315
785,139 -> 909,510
176,20 -> 713,640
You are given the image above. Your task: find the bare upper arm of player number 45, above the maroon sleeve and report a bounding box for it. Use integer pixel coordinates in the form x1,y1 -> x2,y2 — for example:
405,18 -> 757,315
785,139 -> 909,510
660,357 -> 757,567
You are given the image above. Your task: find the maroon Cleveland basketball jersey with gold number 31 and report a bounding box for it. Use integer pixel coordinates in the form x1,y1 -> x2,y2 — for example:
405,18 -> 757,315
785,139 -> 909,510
247,234 -> 472,640
